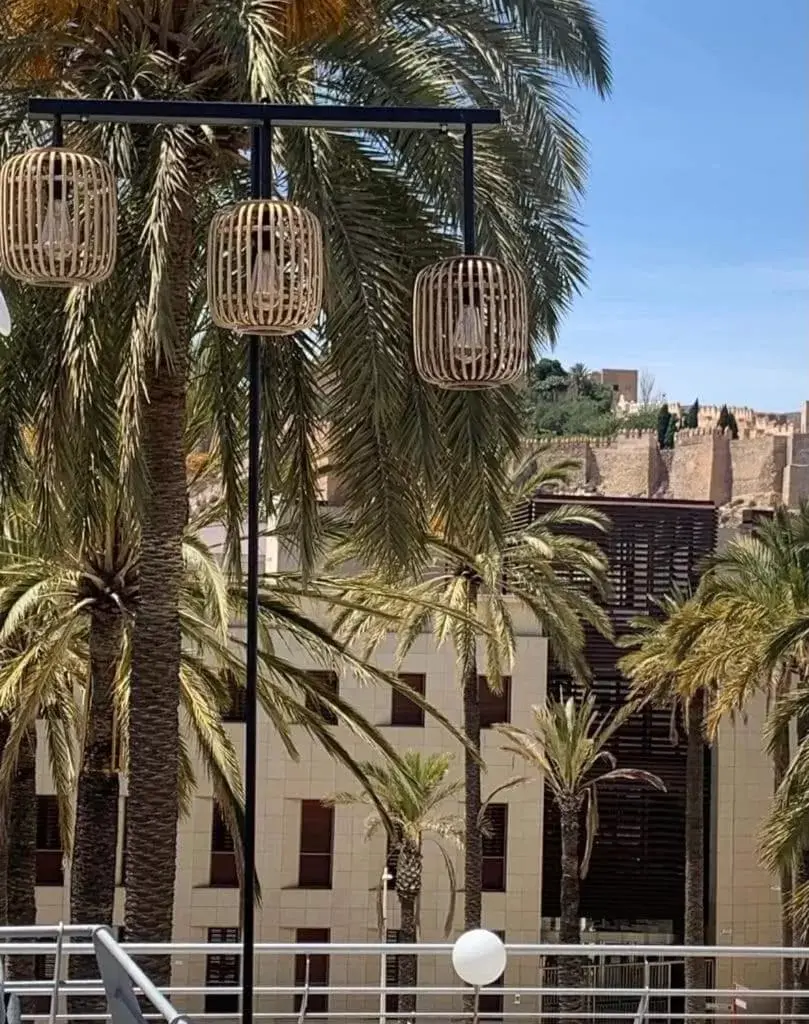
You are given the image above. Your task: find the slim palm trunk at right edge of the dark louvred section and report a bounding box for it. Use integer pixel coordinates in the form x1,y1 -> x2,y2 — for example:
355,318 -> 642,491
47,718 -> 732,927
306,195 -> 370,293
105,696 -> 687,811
685,692 -> 706,1024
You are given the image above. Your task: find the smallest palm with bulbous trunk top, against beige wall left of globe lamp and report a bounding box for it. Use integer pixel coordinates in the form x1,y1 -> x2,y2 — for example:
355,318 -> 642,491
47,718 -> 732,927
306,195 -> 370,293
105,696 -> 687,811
328,751 -> 464,1015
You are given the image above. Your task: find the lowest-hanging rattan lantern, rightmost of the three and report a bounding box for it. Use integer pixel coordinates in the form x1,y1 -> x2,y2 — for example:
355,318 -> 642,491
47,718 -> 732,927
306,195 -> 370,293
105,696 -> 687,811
413,256 -> 528,389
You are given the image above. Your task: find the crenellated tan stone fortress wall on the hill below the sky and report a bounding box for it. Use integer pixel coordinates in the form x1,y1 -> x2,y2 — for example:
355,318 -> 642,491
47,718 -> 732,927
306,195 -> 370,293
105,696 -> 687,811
542,402 -> 809,507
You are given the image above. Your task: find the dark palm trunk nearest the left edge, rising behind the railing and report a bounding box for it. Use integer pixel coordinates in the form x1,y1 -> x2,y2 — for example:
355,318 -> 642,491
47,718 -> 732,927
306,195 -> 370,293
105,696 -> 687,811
6,729 -> 37,1014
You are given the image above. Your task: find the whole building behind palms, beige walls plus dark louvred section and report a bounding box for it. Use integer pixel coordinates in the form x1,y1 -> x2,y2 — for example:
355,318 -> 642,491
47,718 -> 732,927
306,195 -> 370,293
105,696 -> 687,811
28,497 -> 790,1014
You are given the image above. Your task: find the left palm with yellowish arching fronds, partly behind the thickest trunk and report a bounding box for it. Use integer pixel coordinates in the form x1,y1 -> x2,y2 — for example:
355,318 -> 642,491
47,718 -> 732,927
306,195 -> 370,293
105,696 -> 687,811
0,483 -> 446,995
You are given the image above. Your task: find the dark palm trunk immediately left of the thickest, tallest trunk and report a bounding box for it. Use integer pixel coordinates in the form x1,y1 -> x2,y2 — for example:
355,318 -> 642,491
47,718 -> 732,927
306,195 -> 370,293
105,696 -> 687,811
70,609 -> 122,1014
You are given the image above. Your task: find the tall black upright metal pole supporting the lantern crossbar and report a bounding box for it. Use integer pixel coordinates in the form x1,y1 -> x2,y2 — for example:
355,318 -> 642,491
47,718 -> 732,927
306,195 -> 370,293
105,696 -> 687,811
242,119 -> 272,1024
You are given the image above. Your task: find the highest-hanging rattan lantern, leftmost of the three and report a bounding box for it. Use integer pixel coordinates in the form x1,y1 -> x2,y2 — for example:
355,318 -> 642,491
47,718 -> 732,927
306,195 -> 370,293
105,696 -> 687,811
0,146 -> 118,287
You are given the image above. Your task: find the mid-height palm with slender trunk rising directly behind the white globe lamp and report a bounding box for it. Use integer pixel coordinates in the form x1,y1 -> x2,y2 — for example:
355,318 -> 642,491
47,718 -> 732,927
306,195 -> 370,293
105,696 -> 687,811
335,453 -> 611,930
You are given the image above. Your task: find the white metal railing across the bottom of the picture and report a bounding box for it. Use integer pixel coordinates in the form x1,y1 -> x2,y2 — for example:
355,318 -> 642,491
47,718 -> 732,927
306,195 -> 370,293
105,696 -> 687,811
0,926 -> 809,1024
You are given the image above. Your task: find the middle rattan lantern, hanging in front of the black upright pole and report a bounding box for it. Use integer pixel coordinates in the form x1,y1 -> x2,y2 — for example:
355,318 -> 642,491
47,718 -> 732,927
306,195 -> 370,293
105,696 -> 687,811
208,200 -> 324,336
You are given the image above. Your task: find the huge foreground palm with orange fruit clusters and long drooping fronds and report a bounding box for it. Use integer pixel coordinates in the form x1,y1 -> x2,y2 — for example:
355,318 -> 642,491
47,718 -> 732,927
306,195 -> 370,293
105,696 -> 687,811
0,0 -> 609,950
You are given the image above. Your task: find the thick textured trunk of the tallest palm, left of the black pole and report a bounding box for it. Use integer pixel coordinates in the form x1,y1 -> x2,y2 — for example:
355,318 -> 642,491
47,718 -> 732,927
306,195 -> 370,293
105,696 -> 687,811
126,198 -> 194,974
